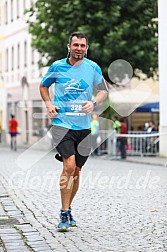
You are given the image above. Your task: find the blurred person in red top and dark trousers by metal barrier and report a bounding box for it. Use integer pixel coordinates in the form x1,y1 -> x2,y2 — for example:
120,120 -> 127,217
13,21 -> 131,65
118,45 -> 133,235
120,118 -> 127,159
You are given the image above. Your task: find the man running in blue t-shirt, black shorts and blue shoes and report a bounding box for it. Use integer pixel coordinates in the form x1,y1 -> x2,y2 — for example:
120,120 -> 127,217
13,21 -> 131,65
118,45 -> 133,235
40,32 -> 108,231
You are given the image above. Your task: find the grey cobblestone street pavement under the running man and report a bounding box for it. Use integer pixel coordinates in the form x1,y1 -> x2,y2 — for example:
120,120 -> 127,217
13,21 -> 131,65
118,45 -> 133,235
0,148 -> 167,252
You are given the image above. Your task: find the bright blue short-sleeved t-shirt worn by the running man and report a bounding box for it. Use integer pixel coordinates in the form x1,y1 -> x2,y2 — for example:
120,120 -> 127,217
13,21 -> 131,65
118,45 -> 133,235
42,58 -> 103,130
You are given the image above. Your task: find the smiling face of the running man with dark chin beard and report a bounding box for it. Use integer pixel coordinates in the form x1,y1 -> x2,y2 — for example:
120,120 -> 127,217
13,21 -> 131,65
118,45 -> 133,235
68,36 -> 88,61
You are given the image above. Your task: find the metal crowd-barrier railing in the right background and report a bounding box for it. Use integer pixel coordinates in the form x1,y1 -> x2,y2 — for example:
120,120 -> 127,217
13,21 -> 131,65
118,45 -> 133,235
97,130 -> 159,156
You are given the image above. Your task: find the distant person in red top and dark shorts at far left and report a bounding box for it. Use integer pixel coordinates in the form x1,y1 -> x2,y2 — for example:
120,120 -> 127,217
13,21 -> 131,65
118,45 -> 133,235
9,115 -> 18,151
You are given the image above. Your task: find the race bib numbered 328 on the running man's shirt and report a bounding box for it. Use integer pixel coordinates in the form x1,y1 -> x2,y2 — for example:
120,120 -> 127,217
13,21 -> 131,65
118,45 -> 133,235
65,101 -> 86,116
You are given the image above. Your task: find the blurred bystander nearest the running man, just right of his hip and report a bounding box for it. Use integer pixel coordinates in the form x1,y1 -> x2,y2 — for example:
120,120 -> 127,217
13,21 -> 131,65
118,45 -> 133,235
91,114 -> 99,155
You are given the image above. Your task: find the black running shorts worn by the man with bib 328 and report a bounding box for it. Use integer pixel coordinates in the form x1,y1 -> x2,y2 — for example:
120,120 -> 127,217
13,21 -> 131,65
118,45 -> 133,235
51,125 -> 91,168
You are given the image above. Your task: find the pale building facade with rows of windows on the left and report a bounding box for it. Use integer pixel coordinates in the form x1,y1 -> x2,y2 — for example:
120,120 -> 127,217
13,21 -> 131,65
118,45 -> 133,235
0,0 -> 48,144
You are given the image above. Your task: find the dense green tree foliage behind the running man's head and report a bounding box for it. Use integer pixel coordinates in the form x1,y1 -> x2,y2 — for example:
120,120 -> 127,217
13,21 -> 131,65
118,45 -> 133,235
27,0 -> 158,81
